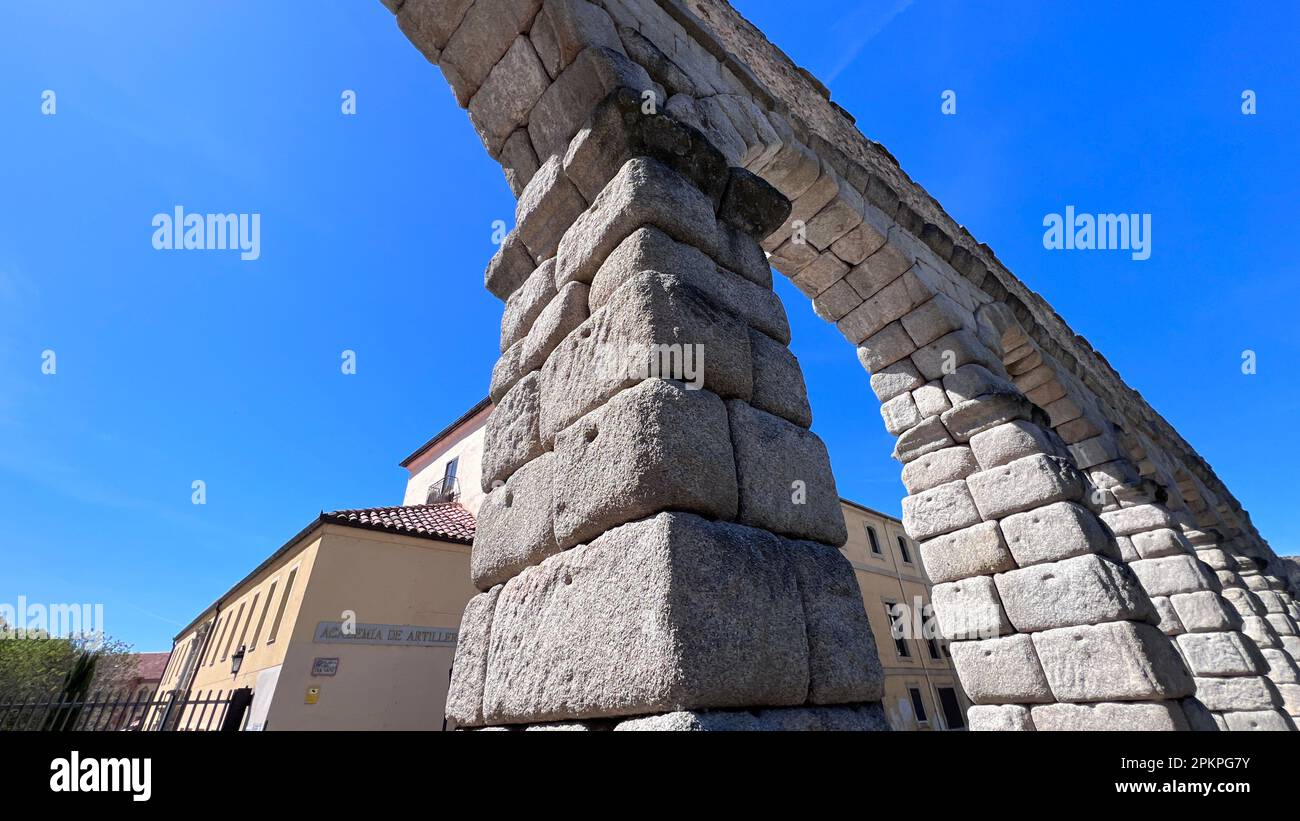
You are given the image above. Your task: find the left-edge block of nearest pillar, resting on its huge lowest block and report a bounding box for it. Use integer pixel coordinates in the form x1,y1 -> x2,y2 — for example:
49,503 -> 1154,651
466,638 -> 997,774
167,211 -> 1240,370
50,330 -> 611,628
469,453 -> 559,590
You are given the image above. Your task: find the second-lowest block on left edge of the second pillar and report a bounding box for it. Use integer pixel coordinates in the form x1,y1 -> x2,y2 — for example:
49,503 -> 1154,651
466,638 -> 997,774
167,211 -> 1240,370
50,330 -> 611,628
949,633 -> 1052,704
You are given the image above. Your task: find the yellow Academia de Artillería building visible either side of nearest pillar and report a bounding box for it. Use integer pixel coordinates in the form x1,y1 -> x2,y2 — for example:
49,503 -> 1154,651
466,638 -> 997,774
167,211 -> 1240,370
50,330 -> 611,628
161,399 -> 967,730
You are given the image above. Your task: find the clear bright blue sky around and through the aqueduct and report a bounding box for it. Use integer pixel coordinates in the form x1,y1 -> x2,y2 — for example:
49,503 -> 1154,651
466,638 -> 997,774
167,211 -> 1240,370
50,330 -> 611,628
0,0 -> 1300,650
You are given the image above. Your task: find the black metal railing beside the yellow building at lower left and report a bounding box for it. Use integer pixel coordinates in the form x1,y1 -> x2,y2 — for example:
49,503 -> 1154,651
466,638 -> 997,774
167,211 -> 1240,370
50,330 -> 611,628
0,687 -> 252,733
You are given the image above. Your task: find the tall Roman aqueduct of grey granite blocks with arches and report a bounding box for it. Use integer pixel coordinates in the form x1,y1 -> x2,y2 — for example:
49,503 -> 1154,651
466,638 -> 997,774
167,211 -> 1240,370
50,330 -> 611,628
384,0 -> 1300,730
